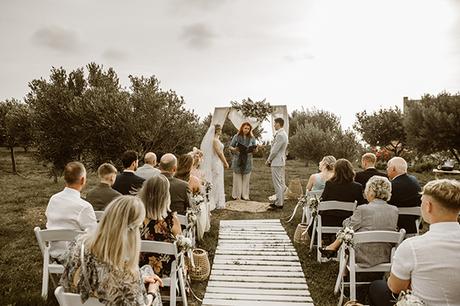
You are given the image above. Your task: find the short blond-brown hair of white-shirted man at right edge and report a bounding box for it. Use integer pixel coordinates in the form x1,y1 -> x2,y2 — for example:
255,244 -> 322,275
422,179 -> 460,213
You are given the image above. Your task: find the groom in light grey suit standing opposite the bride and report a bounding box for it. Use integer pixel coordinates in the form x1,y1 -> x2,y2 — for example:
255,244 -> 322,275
265,118 -> 288,210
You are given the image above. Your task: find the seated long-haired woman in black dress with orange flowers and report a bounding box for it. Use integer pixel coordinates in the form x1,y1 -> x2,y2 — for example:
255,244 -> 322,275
139,175 -> 181,277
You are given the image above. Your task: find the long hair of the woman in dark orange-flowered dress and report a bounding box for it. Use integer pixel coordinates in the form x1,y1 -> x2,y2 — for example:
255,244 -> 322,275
139,174 -> 171,220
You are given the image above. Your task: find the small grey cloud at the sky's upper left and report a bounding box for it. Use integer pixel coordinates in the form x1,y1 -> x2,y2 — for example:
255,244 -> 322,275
32,26 -> 81,52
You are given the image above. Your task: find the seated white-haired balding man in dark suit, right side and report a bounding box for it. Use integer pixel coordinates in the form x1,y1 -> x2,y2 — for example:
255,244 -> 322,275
387,157 -> 421,234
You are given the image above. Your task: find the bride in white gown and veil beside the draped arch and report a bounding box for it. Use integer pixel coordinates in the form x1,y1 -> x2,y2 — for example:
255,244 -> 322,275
201,124 -> 228,210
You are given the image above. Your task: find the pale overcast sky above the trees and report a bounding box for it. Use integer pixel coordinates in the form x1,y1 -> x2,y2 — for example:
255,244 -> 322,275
0,0 -> 460,136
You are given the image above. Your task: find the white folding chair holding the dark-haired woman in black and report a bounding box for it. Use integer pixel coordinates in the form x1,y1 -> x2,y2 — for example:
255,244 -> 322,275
310,201 -> 356,262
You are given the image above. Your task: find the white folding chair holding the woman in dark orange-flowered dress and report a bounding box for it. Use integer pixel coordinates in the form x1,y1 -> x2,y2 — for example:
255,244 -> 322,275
141,240 -> 187,306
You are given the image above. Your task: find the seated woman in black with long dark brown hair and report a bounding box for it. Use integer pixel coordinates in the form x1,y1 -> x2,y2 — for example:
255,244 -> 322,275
320,158 -> 365,226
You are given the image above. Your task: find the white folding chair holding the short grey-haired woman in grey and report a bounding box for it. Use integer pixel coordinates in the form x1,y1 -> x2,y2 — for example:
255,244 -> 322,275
334,229 -> 406,305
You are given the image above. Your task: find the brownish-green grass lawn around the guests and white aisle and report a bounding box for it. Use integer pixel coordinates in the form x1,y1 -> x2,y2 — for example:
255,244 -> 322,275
0,149 -> 434,306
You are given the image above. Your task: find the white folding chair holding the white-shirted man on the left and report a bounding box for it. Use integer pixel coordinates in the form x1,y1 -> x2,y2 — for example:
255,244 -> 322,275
34,226 -> 84,299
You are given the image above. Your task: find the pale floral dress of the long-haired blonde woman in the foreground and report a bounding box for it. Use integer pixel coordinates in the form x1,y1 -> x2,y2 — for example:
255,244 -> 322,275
59,239 -> 155,306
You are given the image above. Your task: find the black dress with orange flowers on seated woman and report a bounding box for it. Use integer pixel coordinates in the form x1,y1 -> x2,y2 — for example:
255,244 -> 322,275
139,212 -> 176,277
